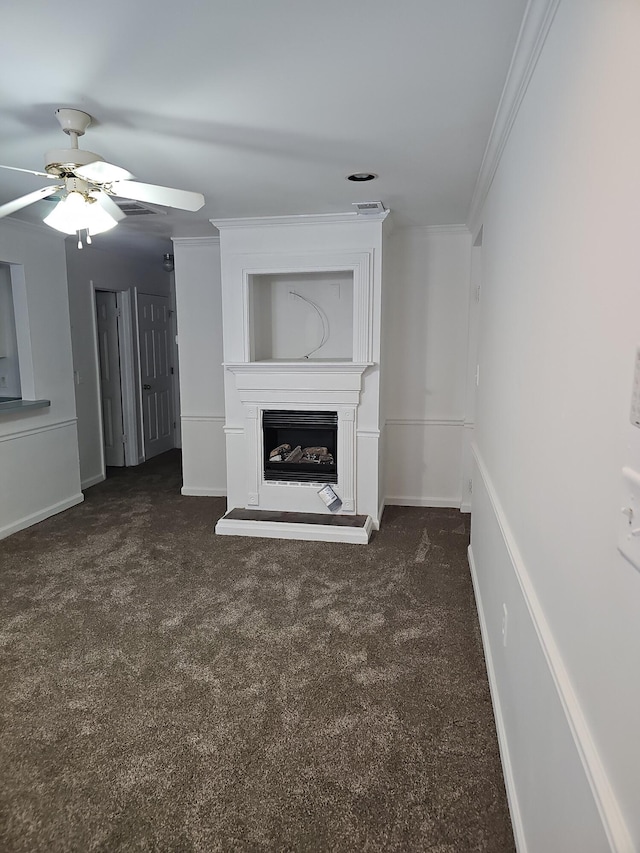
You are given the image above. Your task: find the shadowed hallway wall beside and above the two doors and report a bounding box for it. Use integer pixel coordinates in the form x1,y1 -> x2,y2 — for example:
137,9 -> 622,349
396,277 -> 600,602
66,243 -> 172,488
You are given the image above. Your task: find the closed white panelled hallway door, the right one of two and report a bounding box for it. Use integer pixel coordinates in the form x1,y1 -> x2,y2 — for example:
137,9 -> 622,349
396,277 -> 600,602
136,293 -> 174,459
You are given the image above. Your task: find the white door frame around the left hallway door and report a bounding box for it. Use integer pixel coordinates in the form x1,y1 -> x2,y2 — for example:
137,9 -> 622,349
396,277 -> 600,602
90,279 -> 142,479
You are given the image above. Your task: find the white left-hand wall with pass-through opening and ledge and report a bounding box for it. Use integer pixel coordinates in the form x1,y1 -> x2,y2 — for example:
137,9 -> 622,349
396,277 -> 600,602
0,219 -> 83,537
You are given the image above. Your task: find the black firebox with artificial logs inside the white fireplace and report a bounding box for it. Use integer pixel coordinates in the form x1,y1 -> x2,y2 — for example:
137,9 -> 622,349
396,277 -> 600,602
262,410 -> 338,483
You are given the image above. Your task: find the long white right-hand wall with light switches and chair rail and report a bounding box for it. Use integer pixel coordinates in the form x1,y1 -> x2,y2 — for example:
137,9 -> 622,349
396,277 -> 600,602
471,0 -> 640,853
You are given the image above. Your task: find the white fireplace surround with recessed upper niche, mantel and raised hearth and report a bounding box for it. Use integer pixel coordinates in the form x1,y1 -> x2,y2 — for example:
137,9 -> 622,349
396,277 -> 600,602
212,211 -> 387,543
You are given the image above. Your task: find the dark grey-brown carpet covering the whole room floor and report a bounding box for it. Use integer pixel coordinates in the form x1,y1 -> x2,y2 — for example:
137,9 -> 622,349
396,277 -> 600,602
0,452 -> 514,853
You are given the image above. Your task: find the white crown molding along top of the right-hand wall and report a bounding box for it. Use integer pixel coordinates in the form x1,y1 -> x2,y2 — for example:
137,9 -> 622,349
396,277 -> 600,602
467,0 -> 560,235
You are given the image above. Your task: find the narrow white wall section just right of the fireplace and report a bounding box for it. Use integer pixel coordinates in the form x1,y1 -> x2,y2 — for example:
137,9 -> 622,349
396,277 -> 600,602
384,226 -> 471,507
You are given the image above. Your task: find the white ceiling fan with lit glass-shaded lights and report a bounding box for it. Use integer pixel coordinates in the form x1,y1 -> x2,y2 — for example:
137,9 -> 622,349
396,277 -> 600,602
0,109 -> 204,249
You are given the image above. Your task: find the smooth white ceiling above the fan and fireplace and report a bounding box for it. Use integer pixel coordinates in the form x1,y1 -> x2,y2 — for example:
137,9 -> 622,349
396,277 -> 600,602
0,0 -> 526,250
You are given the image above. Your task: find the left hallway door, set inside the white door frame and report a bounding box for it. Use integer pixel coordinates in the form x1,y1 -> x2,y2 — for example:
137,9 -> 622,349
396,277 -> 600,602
96,290 -> 124,467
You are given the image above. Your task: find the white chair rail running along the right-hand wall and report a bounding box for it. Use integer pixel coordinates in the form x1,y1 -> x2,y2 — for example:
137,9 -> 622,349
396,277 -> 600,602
471,442 -> 636,853
